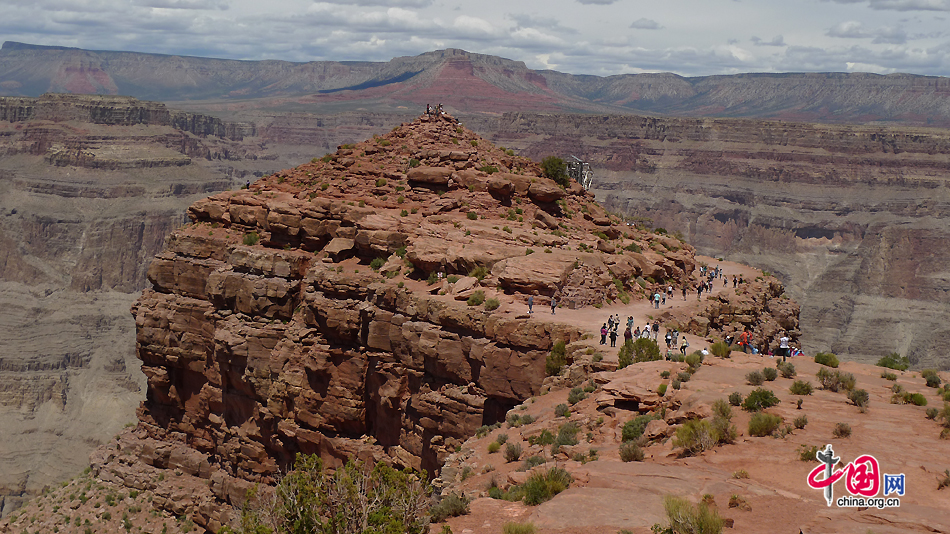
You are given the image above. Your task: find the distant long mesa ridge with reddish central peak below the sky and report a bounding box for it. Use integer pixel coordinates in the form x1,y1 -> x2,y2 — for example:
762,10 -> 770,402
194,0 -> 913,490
0,42 -> 950,127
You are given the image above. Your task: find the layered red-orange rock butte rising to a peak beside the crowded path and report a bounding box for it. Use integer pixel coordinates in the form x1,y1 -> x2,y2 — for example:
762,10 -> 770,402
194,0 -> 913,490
0,116 -> 798,531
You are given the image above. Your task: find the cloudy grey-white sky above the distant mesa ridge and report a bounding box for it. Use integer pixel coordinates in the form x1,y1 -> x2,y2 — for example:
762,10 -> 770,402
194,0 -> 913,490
0,0 -> 950,76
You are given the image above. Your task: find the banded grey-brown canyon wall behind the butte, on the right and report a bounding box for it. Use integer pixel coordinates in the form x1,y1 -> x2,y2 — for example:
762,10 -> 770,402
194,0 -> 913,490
480,114 -> 950,368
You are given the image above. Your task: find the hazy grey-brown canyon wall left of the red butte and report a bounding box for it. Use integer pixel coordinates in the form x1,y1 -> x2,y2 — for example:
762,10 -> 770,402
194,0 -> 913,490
0,95 -> 299,513
